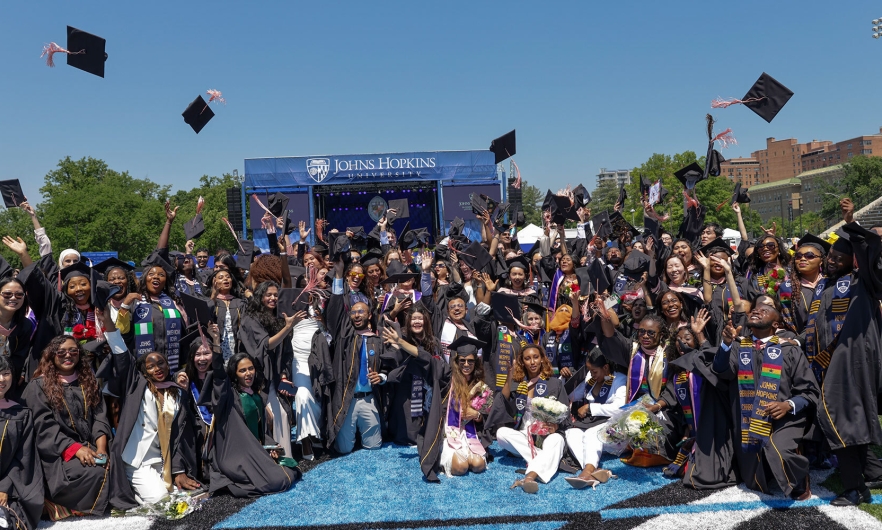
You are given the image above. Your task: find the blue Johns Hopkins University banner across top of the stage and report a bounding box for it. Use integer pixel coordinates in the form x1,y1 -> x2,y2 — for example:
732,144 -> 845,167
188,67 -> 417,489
245,150 -> 498,189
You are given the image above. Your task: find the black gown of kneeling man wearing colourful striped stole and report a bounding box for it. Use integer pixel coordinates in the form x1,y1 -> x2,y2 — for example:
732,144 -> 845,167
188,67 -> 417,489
708,342 -> 816,495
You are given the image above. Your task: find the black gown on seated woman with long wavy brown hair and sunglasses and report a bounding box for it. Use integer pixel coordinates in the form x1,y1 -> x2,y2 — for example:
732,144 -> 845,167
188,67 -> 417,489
24,376 -> 138,515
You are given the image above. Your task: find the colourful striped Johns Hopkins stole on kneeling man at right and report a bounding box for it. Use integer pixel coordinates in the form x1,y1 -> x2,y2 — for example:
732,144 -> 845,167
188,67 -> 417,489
738,336 -> 784,453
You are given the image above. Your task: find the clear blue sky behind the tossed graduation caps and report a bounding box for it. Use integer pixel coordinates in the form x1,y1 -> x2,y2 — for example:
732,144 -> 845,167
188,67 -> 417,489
0,0 -> 882,202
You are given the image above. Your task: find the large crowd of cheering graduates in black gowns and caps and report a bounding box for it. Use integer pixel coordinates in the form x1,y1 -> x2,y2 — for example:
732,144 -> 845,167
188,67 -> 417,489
0,179 -> 882,529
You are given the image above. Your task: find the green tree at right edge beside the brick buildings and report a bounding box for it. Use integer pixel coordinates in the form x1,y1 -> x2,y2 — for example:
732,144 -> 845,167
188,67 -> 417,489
816,155 -> 882,223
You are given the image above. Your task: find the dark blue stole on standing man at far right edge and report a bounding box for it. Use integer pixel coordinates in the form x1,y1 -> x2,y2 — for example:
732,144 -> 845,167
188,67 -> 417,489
805,274 -> 852,383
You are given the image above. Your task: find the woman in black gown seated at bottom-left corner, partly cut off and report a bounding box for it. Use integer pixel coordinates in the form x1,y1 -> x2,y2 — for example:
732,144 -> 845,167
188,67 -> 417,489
0,355 -> 43,530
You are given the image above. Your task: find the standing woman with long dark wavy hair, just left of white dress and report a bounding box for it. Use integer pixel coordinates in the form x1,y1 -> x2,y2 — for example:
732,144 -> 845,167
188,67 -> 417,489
239,282 -> 307,462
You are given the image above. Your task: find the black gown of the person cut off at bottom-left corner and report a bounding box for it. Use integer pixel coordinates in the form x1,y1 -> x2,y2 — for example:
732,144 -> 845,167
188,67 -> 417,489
0,403 -> 43,530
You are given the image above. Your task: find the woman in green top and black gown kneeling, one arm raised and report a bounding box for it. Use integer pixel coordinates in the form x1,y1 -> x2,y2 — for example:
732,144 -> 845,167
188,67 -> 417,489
198,326 -> 301,497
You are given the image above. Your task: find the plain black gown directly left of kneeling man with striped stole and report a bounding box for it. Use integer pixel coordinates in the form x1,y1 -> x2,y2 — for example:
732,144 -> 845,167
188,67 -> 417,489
671,341 -> 738,490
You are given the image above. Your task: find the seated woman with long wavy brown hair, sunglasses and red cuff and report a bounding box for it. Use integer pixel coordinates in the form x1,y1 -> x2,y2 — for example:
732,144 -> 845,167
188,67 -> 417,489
24,335 -> 138,520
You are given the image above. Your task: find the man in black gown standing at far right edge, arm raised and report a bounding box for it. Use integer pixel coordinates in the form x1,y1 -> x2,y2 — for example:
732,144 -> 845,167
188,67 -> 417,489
805,205 -> 882,506
